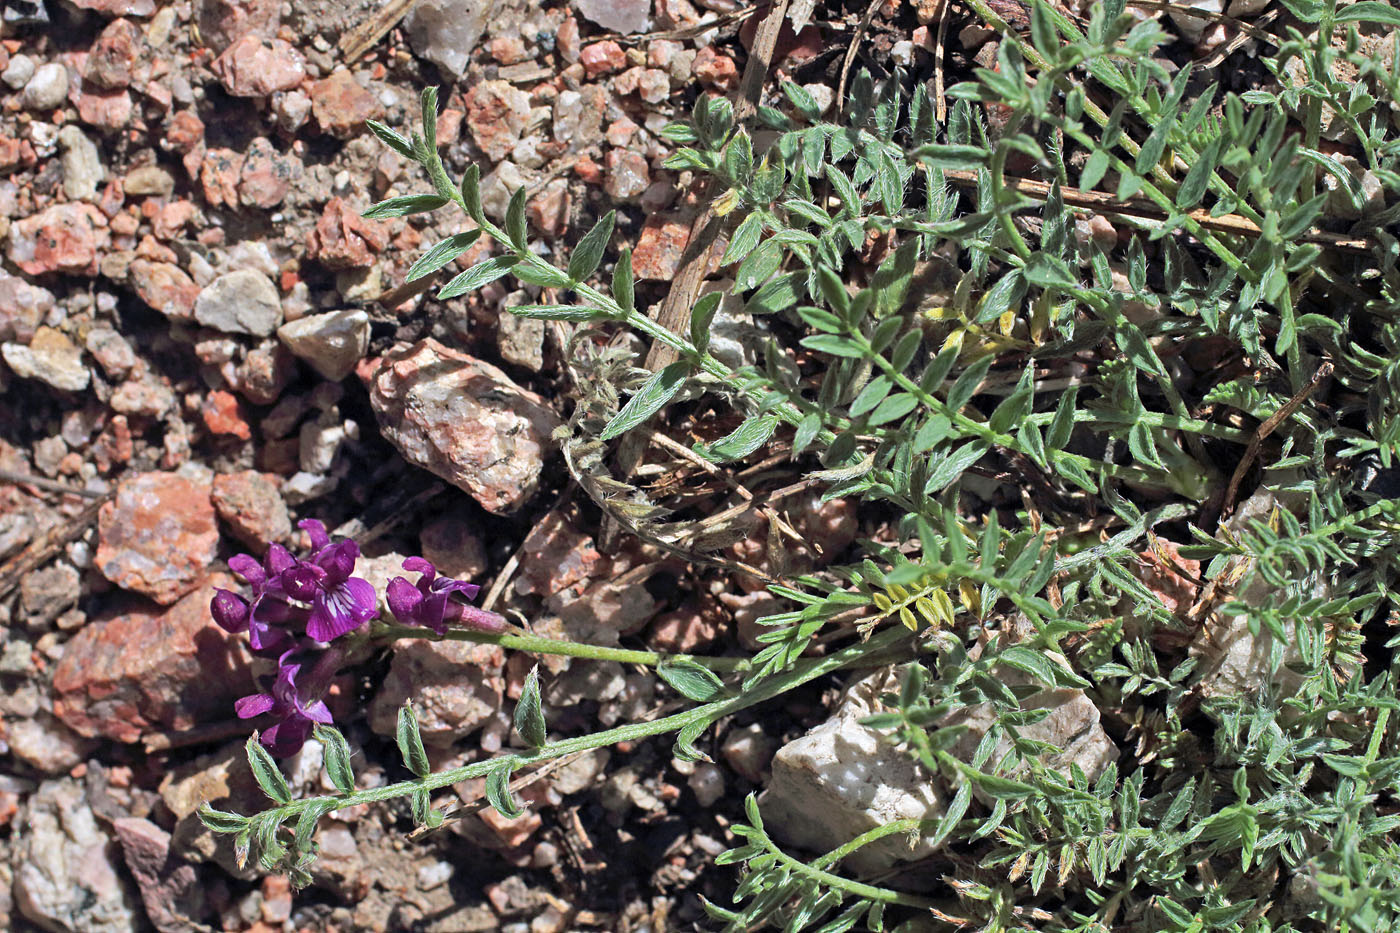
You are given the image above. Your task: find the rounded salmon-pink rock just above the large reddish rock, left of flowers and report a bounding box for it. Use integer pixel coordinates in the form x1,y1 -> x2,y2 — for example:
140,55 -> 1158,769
97,472 -> 218,605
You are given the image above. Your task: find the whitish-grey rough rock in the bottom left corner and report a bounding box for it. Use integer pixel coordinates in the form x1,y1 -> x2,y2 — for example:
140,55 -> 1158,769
11,778 -> 141,933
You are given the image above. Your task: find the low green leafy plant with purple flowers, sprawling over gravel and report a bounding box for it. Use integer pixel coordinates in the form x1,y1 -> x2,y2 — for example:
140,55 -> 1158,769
203,0 -> 1400,933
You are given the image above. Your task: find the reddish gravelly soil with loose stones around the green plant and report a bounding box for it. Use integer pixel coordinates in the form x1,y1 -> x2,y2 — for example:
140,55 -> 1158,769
0,0 -> 1321,933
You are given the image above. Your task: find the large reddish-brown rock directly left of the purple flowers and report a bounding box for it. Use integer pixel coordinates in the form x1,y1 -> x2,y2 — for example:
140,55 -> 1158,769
53,574 -> 253,742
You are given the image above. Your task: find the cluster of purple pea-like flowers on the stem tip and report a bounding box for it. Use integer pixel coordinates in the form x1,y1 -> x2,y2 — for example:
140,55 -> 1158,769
209,518 -> 505,755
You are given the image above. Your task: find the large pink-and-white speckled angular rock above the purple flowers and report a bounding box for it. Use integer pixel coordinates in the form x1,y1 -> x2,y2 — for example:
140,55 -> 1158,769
370,339 -> 560,513
